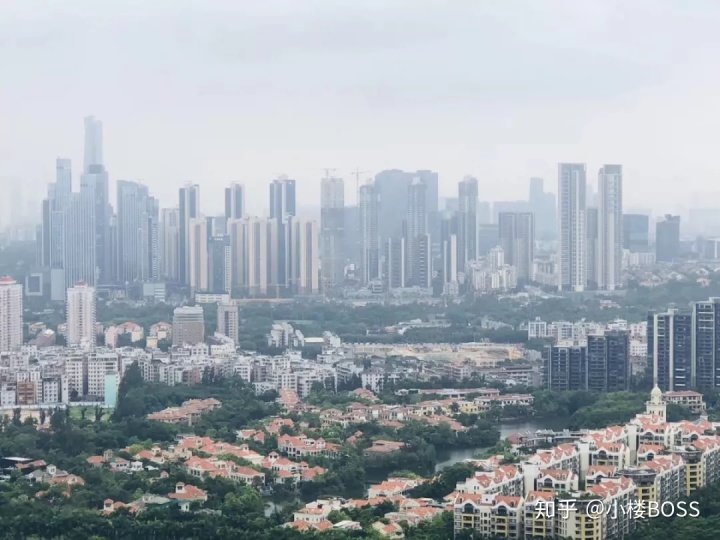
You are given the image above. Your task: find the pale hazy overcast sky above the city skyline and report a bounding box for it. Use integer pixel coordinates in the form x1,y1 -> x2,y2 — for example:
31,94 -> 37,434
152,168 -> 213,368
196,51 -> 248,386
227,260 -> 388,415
0,0 -> 720,213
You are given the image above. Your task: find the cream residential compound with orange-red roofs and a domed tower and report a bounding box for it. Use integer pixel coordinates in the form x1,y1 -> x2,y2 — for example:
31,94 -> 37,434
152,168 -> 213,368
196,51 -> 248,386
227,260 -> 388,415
446,387 -> 720,540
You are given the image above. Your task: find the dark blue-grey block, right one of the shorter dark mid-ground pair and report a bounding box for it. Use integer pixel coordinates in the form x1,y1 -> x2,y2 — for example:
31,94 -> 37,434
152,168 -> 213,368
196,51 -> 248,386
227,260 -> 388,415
587,330 -> 630,393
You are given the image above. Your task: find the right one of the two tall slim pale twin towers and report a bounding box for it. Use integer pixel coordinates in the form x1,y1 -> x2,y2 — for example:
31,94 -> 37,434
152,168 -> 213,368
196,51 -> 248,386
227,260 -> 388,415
597,165 -> 623,291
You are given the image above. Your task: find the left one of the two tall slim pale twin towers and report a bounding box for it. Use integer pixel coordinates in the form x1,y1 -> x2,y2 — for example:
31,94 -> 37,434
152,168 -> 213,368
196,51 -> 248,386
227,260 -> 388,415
558,163 -> 587,291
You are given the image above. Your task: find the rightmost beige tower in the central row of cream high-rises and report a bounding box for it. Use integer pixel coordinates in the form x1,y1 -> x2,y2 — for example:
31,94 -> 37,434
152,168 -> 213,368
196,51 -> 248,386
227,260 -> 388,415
288,217 -> 320,296
